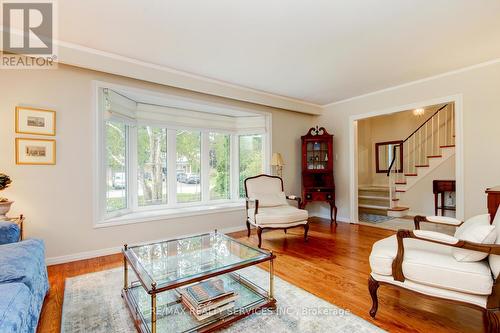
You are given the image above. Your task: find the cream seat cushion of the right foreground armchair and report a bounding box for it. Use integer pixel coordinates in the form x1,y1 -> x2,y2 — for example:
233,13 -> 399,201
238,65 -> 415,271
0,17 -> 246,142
370,236 -> 493,295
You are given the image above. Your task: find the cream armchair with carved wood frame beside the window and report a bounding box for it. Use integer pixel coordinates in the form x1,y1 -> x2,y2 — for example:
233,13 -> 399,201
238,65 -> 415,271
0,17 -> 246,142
245,175 -> 309,247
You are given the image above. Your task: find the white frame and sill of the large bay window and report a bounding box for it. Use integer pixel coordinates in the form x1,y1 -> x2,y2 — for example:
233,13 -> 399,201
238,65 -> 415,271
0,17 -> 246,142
93,81 -> 272,228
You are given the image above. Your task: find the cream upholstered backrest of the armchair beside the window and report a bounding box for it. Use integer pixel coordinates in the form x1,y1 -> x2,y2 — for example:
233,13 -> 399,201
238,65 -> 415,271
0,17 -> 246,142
245,175 -> 287,207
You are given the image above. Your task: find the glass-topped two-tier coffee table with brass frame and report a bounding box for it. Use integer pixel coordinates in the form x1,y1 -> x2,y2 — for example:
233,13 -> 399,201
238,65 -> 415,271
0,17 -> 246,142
122,231 -> 276,333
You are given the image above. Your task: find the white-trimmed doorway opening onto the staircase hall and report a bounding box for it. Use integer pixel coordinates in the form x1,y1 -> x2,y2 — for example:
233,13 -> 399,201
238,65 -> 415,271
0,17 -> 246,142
350,96 -> 463,232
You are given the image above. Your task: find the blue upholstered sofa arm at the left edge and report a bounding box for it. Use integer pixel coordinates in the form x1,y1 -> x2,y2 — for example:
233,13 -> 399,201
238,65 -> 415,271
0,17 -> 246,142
0,239 -> 49,332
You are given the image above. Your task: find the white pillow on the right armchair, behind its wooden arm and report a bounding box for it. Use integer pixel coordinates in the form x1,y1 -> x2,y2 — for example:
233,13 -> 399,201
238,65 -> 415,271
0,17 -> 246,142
453,214 -> 497,262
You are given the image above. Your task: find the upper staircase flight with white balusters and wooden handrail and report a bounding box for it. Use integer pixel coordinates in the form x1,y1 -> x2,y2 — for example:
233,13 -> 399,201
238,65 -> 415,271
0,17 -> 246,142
386,103 -> 455,217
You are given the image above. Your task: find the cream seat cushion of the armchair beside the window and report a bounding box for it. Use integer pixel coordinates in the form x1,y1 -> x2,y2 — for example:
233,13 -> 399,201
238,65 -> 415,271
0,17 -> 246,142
248,205 -> 308,225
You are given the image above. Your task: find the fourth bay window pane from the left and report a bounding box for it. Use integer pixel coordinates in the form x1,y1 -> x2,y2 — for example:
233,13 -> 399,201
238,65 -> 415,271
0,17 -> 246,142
208,133 -> 231,200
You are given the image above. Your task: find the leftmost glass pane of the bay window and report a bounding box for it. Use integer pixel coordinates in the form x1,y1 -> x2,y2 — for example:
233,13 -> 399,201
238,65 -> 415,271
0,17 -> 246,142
105,121 -> 128,212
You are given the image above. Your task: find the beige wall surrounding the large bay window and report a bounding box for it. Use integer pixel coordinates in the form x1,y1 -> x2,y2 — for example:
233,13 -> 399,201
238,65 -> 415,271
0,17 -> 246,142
0,65 -> 312,260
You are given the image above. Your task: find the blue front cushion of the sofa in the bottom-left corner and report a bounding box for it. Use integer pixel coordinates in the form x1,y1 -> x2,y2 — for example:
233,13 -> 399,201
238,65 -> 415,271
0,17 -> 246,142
0,283 -> 31,333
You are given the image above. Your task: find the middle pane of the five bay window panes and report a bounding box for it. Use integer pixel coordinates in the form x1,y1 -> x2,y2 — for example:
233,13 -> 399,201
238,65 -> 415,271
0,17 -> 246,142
176,130 -> 201,202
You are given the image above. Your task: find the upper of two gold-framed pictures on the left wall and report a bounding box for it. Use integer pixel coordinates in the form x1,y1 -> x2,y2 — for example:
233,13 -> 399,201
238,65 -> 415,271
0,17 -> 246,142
16,106 -> 56,136
